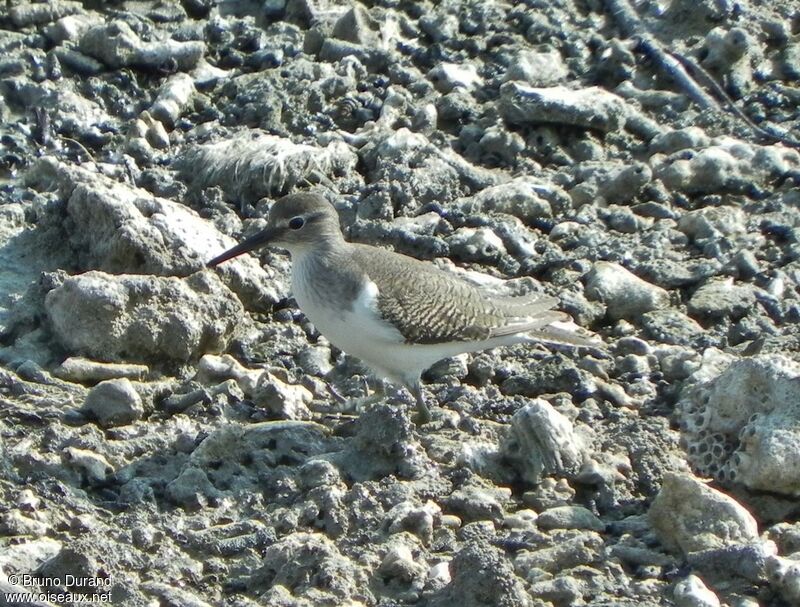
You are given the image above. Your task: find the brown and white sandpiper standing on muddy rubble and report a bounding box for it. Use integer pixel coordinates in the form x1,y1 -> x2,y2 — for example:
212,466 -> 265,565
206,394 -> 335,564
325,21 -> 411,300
206,191 -> 599,423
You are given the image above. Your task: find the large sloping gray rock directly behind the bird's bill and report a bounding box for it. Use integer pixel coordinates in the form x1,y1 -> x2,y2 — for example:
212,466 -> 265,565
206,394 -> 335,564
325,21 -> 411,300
29,157 -> 281,308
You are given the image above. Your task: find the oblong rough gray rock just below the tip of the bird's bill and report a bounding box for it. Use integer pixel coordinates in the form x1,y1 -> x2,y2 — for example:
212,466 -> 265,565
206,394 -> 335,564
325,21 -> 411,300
45,272 -> 244,364
